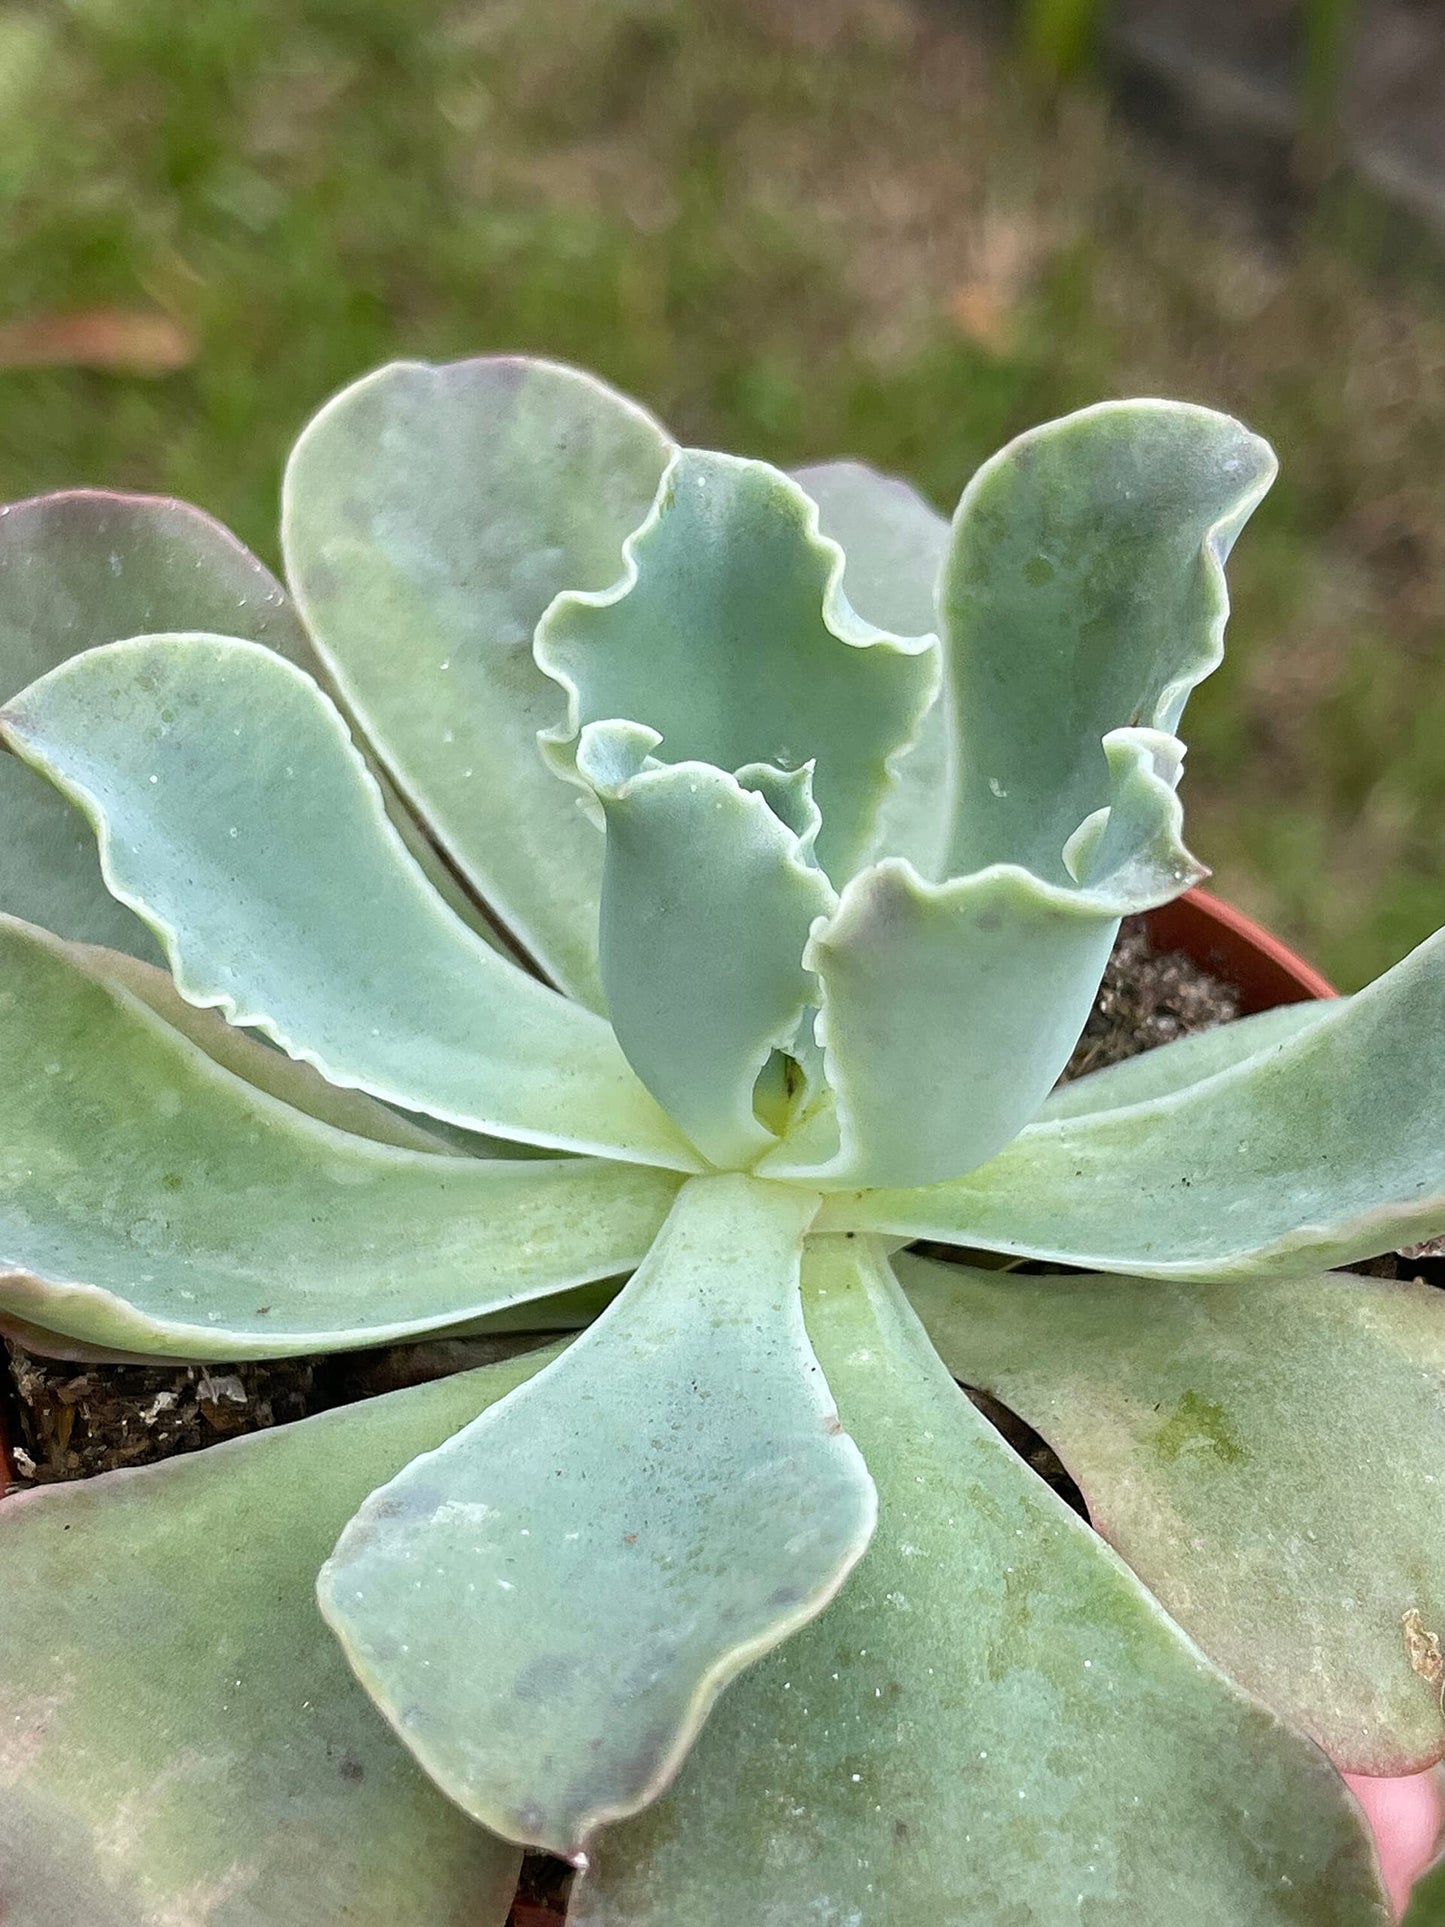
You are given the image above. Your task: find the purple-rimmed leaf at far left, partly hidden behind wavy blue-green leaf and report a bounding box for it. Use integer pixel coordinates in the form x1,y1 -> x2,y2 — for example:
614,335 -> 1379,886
0,489 -> 306,958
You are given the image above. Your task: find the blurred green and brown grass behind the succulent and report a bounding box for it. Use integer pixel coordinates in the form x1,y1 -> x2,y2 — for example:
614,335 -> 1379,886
0,0 -> 1445,987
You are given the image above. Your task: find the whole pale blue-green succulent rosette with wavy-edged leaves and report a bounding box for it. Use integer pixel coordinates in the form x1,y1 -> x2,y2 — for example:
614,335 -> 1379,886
0,358 -> 1445,1927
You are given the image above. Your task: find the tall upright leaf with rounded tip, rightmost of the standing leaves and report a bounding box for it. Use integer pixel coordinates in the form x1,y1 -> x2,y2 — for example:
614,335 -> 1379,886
940,401 -> 1275,883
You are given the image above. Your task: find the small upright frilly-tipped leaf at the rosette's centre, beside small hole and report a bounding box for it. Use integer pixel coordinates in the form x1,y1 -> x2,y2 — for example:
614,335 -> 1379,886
578,723 -> 836,1166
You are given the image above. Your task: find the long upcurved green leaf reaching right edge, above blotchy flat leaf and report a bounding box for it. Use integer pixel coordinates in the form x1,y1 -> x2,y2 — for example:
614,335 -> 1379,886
819,933 -> 1445,1278
